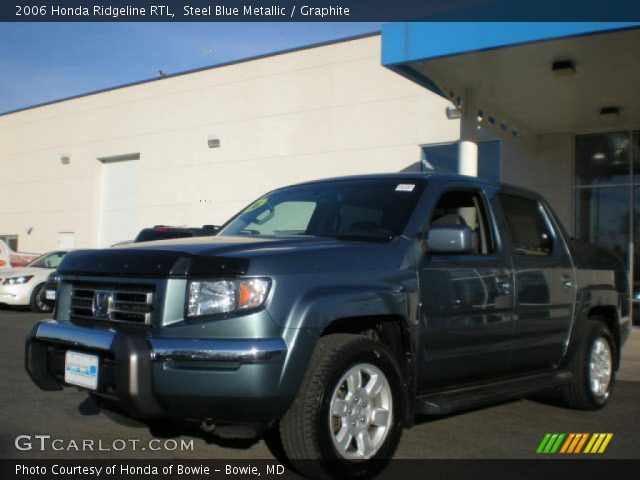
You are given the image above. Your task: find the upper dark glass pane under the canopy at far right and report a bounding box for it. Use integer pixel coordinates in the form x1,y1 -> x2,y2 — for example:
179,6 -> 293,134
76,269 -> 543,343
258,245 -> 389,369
576,132 -> 640,186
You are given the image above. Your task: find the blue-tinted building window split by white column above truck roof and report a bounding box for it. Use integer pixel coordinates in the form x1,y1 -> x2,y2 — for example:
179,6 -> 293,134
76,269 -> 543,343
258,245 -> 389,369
420,140 -> 501,181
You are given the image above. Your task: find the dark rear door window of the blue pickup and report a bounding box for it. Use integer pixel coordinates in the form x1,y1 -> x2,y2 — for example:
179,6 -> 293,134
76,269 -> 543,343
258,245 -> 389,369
499,193 -> 553,256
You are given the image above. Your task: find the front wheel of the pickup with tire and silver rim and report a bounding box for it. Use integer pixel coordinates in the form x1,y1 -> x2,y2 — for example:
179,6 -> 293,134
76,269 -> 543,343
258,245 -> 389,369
279,334 -> 405,479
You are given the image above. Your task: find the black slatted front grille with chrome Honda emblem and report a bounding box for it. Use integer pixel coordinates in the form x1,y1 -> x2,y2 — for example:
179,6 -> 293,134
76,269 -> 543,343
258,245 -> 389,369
71,284 -> 155,325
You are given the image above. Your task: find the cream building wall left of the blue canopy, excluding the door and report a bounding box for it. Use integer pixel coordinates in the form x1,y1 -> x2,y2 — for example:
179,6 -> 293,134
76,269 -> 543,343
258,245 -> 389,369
0,36 -> 460,252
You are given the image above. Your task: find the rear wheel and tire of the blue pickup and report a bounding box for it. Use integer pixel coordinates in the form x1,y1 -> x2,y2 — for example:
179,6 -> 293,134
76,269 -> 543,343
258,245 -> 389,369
562,319 -> 616,410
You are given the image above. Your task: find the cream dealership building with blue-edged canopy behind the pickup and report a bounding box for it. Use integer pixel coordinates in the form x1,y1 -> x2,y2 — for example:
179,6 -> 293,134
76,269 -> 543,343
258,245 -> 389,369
0,23 -> 640,312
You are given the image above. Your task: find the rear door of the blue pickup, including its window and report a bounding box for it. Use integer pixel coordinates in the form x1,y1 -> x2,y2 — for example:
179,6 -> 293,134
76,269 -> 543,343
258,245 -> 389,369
498,190 -> 576,374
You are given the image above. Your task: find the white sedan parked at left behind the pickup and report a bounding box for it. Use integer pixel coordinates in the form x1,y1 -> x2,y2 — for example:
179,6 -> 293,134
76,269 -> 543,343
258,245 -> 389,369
0,251 -> 67,312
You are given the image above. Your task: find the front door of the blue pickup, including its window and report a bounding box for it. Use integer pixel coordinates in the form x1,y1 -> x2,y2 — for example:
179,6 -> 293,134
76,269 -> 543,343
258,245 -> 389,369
418,184 -> 514,392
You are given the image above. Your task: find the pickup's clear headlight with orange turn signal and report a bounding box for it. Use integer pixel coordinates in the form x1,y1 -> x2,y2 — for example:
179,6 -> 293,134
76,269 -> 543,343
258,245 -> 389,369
187,278 -> 271,317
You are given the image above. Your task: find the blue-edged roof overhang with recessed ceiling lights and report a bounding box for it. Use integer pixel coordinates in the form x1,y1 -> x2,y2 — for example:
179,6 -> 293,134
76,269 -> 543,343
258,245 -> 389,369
382,22 -> 640,133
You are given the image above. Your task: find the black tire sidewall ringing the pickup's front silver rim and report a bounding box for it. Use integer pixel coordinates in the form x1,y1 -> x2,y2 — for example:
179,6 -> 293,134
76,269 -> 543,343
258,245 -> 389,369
315,343 -> 405,478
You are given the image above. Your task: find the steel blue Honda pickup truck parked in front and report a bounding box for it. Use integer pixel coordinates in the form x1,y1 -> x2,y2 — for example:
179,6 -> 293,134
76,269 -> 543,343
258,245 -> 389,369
26,173 -> 630,478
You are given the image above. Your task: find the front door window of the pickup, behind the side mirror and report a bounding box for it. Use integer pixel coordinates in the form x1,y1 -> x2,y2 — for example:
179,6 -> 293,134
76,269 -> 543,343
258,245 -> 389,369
429,190 -> 495,255
